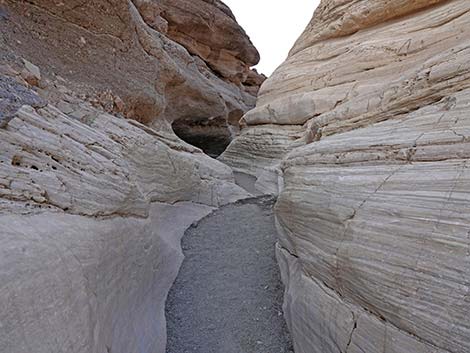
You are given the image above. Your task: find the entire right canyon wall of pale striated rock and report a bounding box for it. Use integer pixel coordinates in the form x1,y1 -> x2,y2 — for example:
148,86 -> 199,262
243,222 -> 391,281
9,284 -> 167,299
221,0 -> 470,353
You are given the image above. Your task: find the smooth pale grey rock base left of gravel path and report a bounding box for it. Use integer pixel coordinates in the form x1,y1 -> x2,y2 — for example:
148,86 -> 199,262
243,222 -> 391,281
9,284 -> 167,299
0,203 -> 215,353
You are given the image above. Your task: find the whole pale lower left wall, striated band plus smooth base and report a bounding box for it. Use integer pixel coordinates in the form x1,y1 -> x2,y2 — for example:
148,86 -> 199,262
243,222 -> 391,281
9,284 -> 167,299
0,74 -> 247,353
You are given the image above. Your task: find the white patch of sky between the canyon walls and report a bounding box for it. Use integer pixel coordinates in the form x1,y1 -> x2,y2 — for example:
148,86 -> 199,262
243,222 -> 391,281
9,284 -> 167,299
222,0 -> 320,76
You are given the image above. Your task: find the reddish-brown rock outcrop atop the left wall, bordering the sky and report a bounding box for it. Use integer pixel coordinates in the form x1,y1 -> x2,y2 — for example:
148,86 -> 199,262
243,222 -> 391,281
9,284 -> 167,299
153,0 -> 260,86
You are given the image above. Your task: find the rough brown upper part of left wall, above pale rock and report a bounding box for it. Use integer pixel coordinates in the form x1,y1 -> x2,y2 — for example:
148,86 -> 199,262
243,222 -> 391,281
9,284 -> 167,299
0,0 -> 262,142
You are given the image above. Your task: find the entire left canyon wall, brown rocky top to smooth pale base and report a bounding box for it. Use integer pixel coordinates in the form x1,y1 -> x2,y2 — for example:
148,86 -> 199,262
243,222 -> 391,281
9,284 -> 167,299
0,0 -> 263,353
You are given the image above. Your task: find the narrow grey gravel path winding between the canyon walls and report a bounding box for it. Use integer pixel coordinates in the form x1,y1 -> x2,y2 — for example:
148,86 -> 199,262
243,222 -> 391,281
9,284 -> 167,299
166,198 -> 292,353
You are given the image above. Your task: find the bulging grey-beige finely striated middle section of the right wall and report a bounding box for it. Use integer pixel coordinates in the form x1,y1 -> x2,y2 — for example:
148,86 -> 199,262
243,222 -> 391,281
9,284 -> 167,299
277,89 -> 470,352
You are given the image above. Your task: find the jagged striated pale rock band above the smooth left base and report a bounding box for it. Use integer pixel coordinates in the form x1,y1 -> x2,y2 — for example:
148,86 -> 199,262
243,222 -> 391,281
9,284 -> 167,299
0,102 -> 246,217
